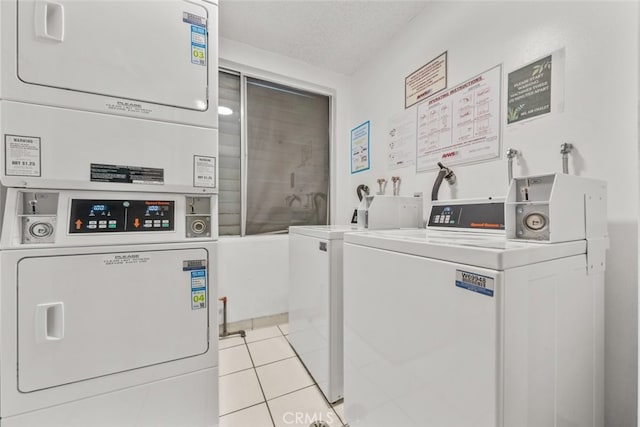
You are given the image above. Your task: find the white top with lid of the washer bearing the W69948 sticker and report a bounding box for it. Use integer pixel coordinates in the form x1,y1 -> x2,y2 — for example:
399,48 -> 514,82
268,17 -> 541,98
344,229 -> 587,270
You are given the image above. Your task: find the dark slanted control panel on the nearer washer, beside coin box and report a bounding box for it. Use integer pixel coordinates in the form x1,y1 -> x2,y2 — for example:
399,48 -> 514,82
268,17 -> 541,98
428,202 -> 504,230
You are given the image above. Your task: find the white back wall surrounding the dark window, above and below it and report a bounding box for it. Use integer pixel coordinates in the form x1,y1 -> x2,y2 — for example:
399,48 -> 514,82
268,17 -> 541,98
218,39 -> 351,322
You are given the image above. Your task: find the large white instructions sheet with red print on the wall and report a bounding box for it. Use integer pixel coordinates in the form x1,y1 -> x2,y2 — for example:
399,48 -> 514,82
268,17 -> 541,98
416,65 -> 502,172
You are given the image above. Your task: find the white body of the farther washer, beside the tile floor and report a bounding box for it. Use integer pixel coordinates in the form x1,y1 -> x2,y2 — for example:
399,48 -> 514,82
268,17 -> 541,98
289,225 -> 357,402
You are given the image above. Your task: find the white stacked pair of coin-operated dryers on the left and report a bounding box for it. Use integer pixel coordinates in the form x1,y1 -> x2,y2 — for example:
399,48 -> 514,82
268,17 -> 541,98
0,0 -> 218,427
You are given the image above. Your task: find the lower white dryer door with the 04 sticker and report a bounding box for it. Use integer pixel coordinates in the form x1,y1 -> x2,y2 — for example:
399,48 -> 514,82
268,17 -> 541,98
18,249 -> 209,392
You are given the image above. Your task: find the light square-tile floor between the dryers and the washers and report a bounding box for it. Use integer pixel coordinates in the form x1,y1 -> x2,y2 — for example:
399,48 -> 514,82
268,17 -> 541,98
219,324 -> 344,427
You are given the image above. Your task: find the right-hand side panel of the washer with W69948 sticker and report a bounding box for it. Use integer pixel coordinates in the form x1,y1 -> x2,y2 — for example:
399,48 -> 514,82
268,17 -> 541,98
502,255 -> 604,427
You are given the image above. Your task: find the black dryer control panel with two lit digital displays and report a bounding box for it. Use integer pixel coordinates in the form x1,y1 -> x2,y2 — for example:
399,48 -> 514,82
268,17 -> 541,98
69,199 -> 175,233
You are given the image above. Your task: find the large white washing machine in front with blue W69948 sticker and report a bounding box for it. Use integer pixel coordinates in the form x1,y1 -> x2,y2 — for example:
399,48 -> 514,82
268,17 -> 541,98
344,175 -> 606,427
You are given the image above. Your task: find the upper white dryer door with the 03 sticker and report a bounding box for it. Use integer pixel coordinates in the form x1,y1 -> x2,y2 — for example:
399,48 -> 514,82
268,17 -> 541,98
17,0 -> 210,110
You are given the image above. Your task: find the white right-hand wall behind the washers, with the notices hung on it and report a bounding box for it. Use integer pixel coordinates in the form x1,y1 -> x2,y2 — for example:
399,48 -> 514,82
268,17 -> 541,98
338,2 -> 639,427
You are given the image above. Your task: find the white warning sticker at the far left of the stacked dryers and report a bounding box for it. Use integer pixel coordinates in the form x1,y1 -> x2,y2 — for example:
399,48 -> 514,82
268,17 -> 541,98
4,134 -> 41,176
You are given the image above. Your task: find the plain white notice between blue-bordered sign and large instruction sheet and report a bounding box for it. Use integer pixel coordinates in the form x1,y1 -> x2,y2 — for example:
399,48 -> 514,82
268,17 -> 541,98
387,108 -> 416,169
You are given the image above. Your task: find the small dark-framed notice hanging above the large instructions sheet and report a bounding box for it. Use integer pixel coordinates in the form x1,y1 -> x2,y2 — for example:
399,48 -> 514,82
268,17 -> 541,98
404,52 -> 447,108
